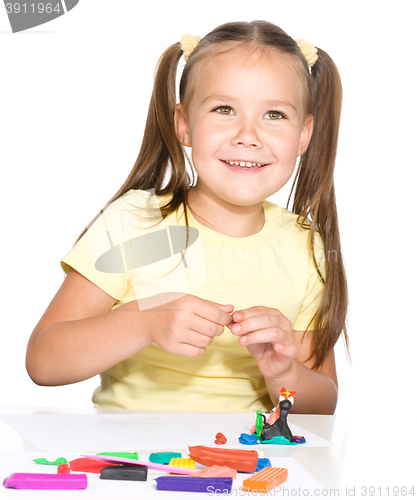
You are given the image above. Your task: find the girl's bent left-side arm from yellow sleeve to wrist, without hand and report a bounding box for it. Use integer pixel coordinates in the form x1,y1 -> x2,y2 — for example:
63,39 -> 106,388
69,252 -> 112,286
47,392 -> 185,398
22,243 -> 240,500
26,269 -> 148,385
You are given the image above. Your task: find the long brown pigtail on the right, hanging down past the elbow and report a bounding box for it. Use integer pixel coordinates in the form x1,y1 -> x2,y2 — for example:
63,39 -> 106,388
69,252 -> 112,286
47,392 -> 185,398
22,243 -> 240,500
290,49 -> 348,368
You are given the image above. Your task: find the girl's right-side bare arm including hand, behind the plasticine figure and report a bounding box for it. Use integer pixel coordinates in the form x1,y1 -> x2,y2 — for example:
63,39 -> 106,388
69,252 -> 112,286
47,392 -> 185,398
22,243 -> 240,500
228,306 -> 337,414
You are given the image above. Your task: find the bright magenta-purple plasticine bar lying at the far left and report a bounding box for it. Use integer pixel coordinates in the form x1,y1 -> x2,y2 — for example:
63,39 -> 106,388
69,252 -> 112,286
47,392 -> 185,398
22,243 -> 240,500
3,472 -> 87,490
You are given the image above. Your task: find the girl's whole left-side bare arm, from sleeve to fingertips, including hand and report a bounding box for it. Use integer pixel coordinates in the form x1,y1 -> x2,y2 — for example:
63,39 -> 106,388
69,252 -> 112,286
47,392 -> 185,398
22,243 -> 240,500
26,269 -> 233,385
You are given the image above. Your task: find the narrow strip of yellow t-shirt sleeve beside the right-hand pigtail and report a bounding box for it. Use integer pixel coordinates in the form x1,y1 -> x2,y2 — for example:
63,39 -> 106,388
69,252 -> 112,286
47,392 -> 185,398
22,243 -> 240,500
294,233 -> 326,331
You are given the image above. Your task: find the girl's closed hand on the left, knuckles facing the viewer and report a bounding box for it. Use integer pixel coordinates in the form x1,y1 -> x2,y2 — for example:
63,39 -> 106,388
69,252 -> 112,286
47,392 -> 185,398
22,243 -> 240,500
141,294 -> 233,357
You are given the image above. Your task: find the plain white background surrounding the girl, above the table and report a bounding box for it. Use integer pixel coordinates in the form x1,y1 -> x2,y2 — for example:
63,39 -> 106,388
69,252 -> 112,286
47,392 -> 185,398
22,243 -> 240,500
0,0 -> 417,418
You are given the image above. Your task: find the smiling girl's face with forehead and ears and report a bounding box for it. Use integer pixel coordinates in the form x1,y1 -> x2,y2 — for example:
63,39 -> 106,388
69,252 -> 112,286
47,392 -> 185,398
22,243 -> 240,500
175,49 -> 313,206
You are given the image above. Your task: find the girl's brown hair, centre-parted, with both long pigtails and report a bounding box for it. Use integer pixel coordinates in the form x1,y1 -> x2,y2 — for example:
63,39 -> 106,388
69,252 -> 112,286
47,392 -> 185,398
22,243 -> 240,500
76,21 -> 348,368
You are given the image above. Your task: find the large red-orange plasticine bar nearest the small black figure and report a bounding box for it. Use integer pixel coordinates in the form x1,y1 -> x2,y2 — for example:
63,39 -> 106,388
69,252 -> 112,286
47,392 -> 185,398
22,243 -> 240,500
188,446 -> 259,472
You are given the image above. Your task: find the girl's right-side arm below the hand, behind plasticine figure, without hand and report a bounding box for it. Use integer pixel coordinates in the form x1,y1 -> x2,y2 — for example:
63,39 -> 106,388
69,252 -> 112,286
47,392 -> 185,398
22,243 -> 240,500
265,331 -> 338,415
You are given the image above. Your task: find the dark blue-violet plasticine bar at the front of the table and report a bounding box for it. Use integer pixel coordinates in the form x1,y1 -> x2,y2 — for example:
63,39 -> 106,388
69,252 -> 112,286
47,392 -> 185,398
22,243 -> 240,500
155,476 -> 233,495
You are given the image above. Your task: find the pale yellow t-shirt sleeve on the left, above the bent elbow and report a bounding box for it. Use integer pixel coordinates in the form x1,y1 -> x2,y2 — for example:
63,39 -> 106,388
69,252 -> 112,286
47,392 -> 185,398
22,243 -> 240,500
61,192 -> 153,300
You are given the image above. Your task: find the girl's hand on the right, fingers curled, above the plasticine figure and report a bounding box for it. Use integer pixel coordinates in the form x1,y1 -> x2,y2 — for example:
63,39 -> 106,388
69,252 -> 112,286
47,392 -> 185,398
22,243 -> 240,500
228,306 -> 298,379
